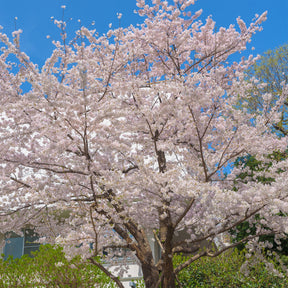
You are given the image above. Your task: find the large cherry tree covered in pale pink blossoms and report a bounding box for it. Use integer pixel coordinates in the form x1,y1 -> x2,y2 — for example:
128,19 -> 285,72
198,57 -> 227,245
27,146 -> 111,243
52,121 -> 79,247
0,0 -> 288,288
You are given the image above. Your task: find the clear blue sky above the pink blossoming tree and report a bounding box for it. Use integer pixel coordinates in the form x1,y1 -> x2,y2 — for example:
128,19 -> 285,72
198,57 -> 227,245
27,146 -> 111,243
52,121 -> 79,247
0,0 -> 288,66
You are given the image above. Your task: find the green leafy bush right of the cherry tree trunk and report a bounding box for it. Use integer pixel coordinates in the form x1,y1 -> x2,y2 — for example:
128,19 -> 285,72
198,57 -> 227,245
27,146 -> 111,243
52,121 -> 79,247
174,250 -> 288,288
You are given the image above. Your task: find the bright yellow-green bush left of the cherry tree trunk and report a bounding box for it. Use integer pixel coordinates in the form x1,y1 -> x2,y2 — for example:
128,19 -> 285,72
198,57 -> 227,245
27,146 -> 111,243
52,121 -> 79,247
0,245 -> 114,288
